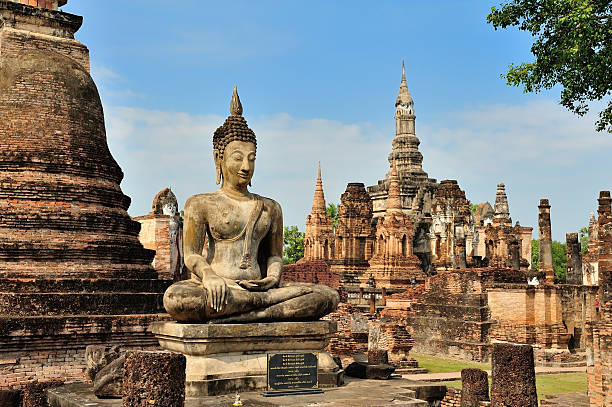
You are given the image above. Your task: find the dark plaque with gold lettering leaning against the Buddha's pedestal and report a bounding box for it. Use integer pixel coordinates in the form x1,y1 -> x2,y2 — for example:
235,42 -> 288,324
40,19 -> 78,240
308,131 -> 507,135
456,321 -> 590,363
268,352 -> 319,391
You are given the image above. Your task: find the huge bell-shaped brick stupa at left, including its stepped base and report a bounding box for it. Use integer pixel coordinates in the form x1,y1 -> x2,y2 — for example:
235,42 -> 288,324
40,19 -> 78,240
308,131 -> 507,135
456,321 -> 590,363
0,1 -> 169,388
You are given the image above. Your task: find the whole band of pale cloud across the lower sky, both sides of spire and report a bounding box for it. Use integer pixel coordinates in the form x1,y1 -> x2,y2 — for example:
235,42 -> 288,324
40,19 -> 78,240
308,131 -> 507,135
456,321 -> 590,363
106,101 -> 612,244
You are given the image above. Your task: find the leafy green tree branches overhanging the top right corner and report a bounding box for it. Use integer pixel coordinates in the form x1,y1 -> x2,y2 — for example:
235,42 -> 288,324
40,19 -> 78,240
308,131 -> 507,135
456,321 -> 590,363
487,0 -> 612,133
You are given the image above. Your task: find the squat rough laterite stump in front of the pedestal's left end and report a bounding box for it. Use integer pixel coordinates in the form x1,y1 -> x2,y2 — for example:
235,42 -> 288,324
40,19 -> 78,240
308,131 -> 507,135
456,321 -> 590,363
123,351 -> 185,407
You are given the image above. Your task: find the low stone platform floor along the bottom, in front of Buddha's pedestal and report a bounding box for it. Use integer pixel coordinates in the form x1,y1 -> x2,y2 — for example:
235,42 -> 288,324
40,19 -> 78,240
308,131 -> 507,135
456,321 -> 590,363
48,378 -> 446,407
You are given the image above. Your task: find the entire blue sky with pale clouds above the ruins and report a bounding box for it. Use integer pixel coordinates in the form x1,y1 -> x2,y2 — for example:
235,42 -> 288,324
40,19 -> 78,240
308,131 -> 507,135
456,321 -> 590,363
63,0 -> 612,241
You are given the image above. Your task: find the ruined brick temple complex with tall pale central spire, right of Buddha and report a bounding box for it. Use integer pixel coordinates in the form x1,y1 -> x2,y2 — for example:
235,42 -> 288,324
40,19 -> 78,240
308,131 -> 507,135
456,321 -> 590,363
304,65 -> 533,288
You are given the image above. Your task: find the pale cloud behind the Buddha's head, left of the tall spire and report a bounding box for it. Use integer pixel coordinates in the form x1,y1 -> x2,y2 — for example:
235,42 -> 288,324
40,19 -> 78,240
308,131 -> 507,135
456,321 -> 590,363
106,108 -> 388,229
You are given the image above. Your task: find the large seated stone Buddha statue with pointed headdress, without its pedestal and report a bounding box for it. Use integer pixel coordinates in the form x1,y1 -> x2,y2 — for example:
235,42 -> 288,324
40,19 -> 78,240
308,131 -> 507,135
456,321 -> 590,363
164,87 -> 339,323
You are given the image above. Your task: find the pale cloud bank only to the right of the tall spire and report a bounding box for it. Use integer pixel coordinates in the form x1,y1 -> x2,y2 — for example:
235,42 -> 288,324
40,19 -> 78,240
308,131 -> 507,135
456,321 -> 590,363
417,100 -> 612,241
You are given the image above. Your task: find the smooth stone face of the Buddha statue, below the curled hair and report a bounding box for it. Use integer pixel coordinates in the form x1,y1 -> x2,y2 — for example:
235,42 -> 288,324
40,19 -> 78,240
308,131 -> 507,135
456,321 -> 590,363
215,140 -> 256,188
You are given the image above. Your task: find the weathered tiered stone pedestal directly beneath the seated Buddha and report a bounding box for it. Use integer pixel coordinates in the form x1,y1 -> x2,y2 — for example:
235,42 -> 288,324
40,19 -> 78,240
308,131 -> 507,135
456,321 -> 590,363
151,321 -> 343,397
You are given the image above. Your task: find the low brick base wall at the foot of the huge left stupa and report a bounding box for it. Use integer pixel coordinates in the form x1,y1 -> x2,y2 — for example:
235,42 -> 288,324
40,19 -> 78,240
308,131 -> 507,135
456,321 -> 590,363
0,315 -> 167,390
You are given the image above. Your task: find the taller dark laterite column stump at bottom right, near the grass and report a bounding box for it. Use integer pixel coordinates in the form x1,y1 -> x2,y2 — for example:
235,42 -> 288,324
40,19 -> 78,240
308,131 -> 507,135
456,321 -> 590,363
491,343 -> 538,407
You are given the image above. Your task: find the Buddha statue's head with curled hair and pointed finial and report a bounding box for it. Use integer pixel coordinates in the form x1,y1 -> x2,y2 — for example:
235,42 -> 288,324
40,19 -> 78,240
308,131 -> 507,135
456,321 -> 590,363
213,86 -> 257,185
